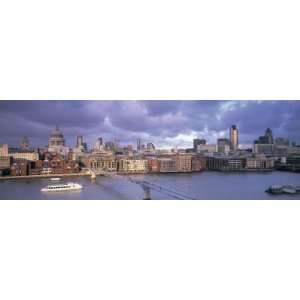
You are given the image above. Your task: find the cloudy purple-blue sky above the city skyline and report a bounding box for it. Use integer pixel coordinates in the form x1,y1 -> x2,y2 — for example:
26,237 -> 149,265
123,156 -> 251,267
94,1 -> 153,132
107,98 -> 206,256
0,100 -> 300,148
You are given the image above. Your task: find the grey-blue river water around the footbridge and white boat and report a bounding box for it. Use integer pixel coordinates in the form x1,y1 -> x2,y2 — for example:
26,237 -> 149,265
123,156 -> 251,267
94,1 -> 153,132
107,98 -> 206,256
0,171 -> 300,200
